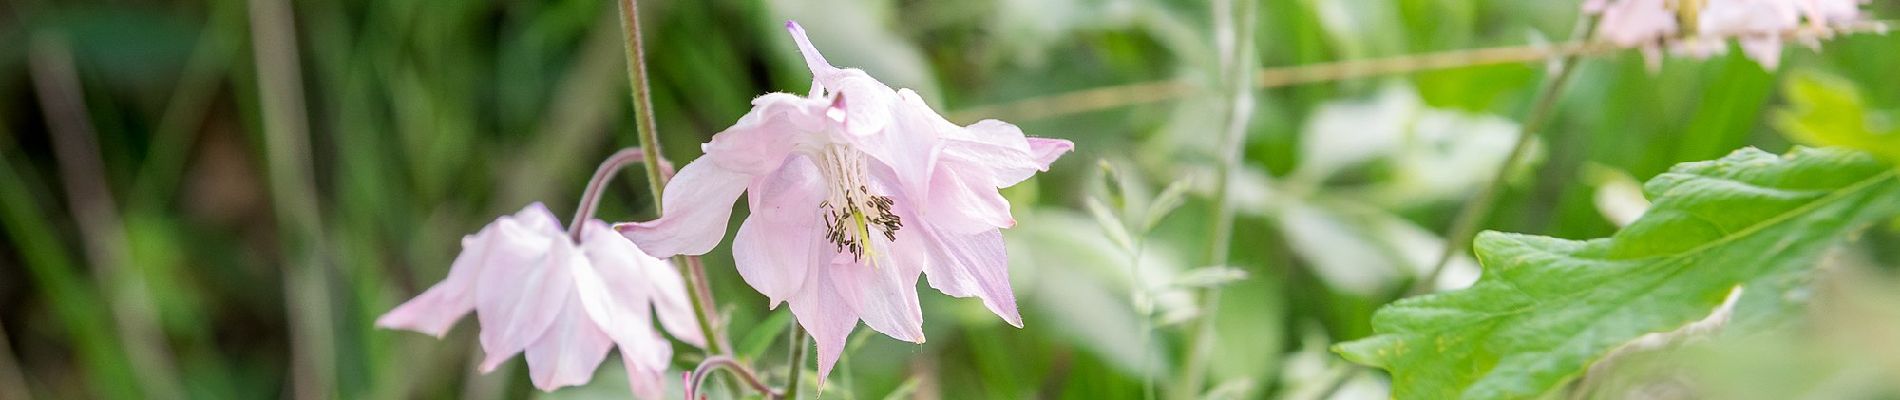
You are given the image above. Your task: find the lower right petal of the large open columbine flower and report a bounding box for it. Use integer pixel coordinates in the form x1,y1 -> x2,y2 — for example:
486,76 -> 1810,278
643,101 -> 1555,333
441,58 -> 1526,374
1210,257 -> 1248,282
912,224 -> 1022,328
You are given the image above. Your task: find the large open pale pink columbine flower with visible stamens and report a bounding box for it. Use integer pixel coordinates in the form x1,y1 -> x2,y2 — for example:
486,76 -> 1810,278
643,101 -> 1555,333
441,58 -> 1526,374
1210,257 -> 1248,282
616,23 -> 1074,379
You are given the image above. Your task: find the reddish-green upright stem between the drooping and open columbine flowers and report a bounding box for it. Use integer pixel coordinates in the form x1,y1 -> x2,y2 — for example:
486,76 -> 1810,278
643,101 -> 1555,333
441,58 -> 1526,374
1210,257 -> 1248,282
619,0 -> 732,355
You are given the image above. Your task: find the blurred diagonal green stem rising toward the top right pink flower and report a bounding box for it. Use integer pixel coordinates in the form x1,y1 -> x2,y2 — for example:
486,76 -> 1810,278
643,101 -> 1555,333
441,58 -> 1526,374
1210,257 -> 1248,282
1408,15 -> 1596,296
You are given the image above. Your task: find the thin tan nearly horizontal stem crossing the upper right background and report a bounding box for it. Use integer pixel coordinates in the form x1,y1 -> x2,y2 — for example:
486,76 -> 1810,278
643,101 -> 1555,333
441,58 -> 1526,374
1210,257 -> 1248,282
950,21 -> 1887,121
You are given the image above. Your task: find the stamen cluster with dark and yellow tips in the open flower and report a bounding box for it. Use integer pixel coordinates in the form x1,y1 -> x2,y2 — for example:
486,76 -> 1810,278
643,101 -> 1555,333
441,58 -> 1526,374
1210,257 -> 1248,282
819,144 -> 904,262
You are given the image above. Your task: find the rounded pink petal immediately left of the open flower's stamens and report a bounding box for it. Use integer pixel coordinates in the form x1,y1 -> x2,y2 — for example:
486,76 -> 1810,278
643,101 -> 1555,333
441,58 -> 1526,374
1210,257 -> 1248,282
732,155 -> 827,307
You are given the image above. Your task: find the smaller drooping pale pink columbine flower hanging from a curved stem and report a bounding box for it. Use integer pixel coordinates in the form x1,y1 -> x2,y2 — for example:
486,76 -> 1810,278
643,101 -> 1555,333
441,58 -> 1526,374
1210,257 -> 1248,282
376,203 -> 705,398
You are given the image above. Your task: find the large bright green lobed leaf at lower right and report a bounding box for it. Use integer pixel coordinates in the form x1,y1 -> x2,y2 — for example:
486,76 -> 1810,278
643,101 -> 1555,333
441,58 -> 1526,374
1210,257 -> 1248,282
1334,148 -> 1900,398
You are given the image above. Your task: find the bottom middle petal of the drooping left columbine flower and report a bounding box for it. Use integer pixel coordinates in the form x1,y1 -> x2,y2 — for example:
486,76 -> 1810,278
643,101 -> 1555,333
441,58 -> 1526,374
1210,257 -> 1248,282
526,282 -> 614,392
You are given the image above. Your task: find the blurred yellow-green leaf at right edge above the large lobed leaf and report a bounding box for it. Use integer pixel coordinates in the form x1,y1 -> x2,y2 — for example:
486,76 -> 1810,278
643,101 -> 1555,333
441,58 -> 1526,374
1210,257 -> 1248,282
1775,72 -> 1900,161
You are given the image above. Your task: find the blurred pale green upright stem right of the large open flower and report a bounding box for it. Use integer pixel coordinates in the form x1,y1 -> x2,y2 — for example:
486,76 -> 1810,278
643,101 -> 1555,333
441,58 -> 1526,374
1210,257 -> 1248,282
1172,0 -> 1258,398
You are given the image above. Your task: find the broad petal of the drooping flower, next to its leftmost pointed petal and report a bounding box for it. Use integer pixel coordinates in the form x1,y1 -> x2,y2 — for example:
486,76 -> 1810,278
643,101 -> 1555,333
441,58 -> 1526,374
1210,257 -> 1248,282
475,228 -> 580,372
